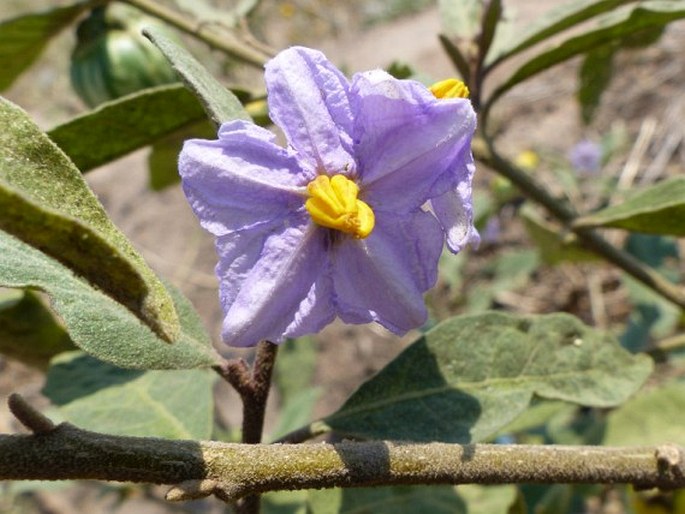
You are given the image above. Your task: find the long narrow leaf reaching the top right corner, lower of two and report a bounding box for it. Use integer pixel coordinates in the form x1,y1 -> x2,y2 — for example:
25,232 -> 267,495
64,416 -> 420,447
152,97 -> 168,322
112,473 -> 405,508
488,0 -> 685,105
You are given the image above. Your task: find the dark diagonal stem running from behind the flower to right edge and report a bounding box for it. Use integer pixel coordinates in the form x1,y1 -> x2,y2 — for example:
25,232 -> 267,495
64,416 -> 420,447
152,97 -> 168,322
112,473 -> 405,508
476,136 -> 685,309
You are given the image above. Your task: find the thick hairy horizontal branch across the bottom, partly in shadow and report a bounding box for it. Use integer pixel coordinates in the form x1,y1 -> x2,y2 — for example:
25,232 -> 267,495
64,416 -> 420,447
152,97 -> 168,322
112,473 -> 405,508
0,412 -> 685,501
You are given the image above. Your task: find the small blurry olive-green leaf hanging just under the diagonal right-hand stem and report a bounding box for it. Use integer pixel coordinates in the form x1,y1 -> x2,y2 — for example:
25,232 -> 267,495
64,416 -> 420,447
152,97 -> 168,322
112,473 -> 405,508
521,206 -> 599,266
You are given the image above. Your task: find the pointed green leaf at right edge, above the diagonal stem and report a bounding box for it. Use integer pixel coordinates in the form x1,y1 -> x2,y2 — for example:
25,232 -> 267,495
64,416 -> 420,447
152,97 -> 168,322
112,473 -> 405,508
574,177 -> 685,237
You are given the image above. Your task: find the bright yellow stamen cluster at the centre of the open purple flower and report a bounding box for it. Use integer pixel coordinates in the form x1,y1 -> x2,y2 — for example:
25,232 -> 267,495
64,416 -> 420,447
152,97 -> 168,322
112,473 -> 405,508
304,175 -> 376,239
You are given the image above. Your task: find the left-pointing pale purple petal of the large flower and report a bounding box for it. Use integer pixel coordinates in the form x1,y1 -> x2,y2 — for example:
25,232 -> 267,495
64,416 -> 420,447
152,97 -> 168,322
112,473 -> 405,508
178,120 -> 313,236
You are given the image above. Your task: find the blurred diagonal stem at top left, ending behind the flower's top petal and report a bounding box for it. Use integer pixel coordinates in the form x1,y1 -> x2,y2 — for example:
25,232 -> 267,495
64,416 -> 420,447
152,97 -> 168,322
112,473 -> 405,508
120,0 -> 271,69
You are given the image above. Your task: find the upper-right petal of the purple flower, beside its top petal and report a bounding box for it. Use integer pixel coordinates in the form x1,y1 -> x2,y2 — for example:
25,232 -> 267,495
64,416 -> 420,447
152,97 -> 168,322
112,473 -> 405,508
352,70 -> 476,211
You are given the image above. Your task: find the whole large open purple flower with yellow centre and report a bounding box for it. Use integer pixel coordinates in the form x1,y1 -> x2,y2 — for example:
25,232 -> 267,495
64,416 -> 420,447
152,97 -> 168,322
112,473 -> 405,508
179,47 -> 478,346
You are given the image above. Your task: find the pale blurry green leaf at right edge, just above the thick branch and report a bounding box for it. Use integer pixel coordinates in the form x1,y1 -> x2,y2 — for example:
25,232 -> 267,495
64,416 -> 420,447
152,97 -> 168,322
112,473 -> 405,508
604,381 -> 685,446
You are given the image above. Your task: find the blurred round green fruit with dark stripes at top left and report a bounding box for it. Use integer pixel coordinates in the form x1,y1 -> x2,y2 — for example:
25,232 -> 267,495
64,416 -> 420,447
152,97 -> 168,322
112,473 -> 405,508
71,3 -> 178,107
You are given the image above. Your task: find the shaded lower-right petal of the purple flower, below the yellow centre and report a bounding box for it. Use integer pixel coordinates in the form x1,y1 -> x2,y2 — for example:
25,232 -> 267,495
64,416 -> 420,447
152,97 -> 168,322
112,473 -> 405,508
331,211 -> 443,335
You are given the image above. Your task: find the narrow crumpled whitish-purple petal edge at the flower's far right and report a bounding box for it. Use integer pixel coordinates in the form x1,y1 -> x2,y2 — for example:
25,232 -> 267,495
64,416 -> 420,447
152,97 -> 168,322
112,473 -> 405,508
430,151 -> 480,253
